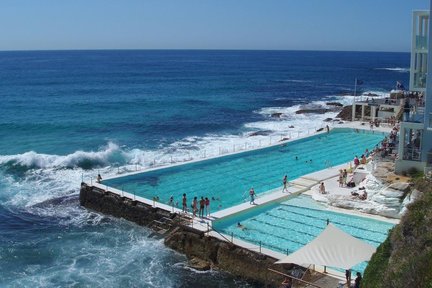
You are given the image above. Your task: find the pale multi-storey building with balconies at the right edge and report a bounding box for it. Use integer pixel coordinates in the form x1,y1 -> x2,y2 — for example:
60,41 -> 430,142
396,9 -> 432,173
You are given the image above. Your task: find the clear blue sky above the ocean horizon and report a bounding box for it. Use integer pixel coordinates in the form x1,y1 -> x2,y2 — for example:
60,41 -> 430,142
0,0 -> 429,51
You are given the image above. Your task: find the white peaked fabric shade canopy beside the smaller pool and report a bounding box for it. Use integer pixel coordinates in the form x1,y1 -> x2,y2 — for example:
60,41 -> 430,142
276,223 -> 376,269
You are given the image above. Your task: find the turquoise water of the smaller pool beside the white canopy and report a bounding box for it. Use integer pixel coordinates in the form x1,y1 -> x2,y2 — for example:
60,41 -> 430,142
213,195 -> 394,272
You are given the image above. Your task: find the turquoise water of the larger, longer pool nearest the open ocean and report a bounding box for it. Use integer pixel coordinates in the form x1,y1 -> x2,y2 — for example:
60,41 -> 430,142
103,129 -> 384,212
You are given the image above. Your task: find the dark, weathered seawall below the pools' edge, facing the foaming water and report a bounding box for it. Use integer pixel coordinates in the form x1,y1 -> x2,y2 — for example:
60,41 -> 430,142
80,183 -> 294,287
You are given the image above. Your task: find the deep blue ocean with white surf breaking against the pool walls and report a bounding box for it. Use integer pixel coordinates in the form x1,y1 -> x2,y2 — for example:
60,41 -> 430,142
0,50 -> 410,287
